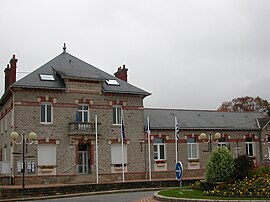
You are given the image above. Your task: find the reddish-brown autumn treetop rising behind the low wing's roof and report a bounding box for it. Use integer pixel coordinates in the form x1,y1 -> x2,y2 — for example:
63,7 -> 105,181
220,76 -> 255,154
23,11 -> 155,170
218,96 -> 270,116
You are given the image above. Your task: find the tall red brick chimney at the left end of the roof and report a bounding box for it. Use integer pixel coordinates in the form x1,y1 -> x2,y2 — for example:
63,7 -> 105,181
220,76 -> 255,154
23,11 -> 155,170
4,55 -> 18,91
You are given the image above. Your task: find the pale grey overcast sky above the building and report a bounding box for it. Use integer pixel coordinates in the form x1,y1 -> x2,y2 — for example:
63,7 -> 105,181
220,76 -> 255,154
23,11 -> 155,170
0,0 -> 270,109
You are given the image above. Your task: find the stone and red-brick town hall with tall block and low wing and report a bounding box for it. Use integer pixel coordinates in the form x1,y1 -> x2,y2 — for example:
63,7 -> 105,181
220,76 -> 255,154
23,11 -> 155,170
0,46 -> 270,183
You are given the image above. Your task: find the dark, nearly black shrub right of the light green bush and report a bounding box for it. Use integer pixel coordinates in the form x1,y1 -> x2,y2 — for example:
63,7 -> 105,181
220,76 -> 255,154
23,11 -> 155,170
234,155 -> 253,180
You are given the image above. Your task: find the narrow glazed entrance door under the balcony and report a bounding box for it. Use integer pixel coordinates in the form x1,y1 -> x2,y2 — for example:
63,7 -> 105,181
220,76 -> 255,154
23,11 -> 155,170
78,144 -> 88,174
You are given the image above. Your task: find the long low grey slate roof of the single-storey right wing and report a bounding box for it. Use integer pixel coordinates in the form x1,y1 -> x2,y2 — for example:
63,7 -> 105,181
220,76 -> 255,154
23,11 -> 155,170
144,108 -> 264,130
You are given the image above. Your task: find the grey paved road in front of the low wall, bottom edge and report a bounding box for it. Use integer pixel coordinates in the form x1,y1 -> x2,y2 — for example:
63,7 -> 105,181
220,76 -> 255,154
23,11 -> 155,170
28,191 -> 156,202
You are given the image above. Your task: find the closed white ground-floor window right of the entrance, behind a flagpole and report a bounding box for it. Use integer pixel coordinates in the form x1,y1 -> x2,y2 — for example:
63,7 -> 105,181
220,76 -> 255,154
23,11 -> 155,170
111,144 -> 128,165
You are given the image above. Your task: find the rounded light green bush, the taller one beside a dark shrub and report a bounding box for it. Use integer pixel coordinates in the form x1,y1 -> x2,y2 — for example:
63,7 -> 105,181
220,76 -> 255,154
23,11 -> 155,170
205,147 -> 235,182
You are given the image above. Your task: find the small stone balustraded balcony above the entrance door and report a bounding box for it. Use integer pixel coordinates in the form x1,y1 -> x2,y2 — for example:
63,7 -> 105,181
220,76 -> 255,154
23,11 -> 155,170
69,122 -> 99,135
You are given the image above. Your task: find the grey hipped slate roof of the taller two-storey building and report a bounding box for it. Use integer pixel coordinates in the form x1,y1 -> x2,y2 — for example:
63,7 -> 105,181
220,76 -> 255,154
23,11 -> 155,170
12,51 -> 150,96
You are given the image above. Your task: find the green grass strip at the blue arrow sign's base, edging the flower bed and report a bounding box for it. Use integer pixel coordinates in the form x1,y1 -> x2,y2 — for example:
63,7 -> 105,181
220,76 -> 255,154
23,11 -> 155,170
158,187 -> 269,200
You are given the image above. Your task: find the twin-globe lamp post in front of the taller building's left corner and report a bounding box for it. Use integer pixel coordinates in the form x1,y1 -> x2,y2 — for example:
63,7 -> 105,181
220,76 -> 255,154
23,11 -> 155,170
10,130 -> 37,189
